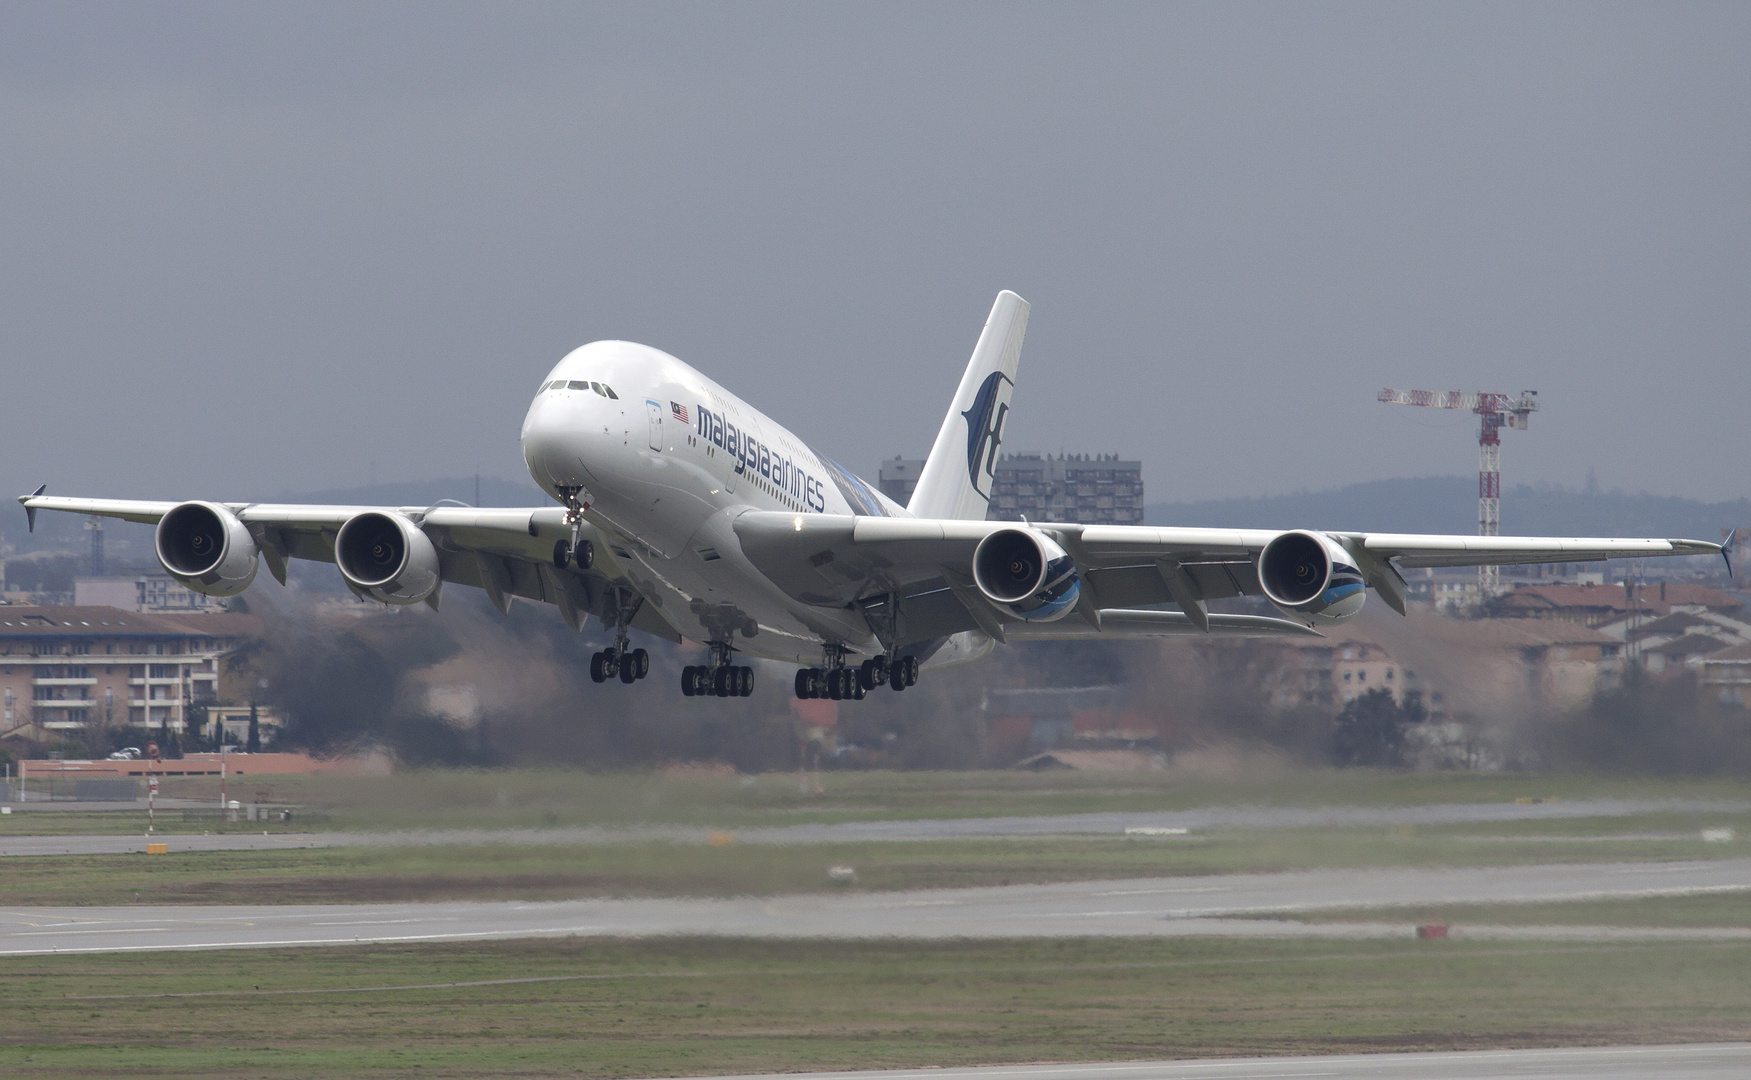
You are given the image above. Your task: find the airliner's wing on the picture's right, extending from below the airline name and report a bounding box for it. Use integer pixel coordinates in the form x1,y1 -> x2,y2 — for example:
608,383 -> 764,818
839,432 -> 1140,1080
735,511 -> 1721,641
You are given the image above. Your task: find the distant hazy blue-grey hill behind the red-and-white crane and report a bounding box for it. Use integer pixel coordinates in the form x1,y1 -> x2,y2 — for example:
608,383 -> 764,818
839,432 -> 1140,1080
1143,476 -> 1751,541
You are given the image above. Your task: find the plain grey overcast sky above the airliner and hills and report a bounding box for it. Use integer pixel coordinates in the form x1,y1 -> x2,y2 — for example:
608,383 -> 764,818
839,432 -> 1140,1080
0,0 -> 1751,501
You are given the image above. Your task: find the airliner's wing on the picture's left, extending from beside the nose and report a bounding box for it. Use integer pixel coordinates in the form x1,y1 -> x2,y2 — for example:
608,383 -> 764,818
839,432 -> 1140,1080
19,494 -> 681,641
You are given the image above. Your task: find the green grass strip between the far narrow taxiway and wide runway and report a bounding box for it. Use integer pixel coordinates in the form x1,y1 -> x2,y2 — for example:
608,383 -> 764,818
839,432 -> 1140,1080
0,823 -> 1751,905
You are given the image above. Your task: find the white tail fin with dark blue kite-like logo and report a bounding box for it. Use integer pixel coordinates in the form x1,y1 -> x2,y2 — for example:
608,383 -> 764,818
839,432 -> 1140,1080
907,289 -> 1028,520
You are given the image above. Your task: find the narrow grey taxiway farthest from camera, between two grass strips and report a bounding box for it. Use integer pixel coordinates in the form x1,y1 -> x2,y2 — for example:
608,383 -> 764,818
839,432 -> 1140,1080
0,798 -> 1751,856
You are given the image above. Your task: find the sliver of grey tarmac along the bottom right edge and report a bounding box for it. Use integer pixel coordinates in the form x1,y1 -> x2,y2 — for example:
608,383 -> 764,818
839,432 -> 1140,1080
672,1043 -> 1751,1080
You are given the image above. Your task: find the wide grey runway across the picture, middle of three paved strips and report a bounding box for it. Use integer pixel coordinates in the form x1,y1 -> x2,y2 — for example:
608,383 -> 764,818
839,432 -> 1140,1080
0,859 -> 1751,954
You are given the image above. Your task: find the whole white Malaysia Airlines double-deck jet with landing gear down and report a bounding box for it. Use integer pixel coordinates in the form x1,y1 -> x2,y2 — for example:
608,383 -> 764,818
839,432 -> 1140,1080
19,292 -> 1721,698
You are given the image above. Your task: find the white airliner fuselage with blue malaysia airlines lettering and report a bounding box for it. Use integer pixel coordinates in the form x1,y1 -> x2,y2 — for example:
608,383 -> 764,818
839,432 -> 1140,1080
522,341 -> 905,663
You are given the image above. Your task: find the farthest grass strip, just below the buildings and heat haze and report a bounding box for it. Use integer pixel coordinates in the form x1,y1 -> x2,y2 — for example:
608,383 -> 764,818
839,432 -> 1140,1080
0,760 -> 1751,835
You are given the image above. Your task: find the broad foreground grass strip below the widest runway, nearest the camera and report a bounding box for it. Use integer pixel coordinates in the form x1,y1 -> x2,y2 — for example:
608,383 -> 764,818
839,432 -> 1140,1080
0,938 -> 1751,1078
